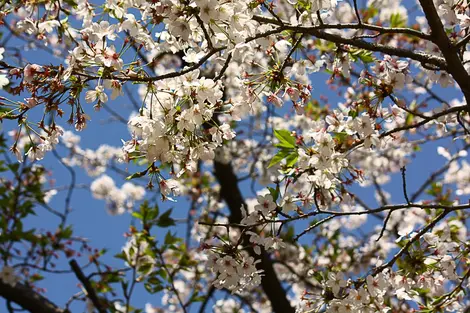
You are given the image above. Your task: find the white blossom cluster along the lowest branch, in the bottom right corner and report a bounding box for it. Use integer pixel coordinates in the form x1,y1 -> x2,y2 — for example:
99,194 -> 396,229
301,218 -> 466,312
